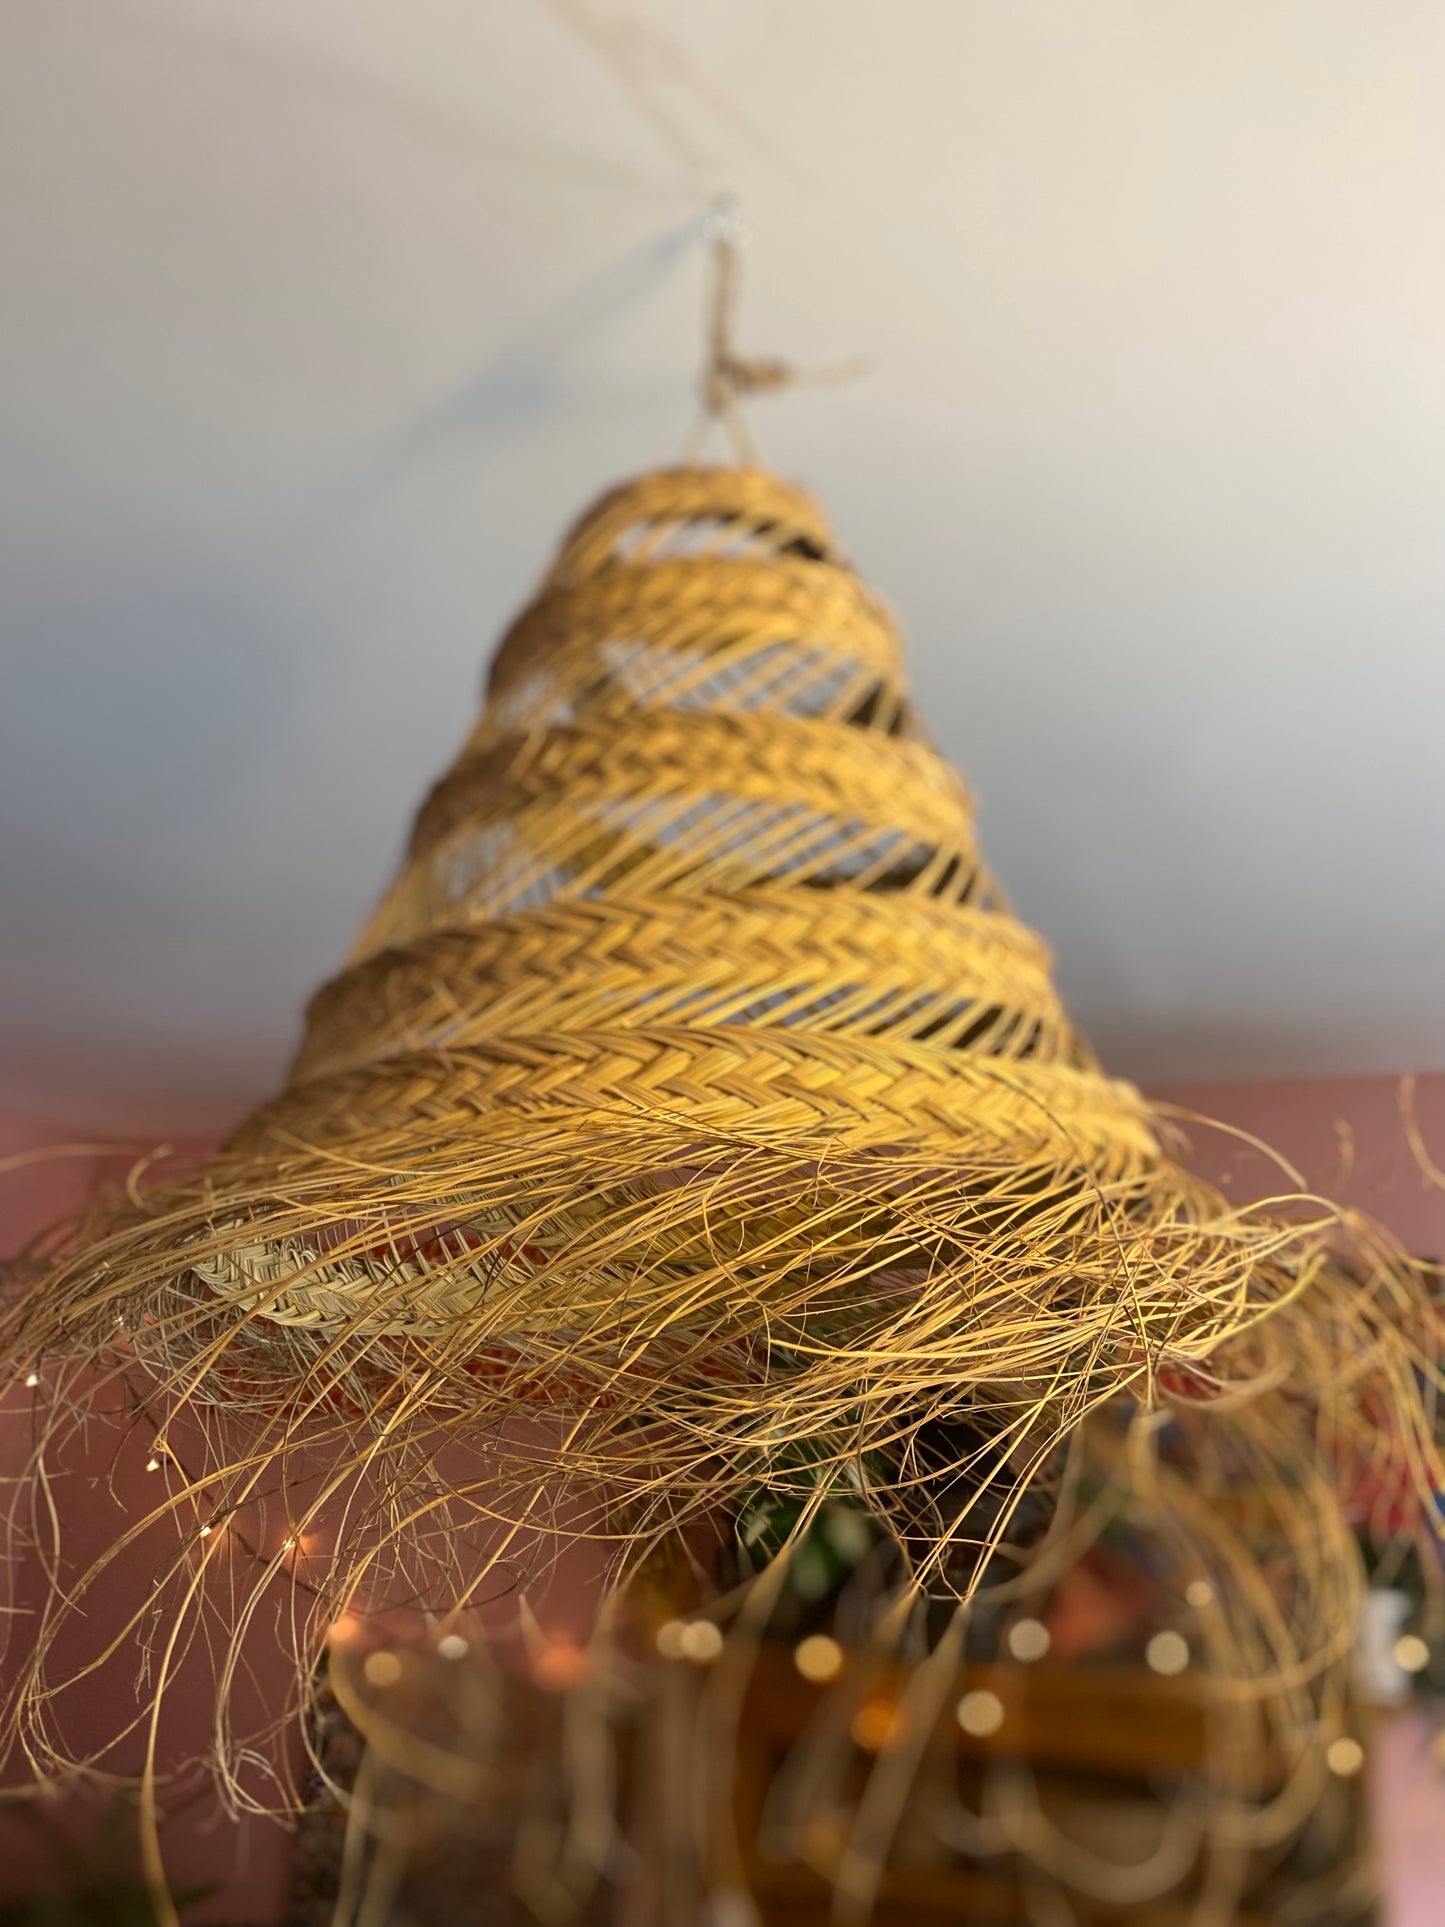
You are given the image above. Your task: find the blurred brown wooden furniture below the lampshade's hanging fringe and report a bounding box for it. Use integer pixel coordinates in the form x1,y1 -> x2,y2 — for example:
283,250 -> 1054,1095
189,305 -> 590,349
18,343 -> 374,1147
289,1644 -> 1374,1927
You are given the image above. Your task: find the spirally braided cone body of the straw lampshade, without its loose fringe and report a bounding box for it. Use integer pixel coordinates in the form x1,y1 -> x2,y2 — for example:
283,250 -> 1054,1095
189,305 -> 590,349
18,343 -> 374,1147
195,470 -> 1186,1372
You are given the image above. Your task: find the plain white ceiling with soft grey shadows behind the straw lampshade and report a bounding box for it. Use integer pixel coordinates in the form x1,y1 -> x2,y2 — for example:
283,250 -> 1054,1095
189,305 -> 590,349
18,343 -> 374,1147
0,0 -> 1445,1127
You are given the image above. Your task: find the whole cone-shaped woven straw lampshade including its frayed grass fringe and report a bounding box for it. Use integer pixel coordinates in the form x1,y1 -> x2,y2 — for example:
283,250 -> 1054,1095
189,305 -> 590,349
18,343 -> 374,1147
4,468 -> 1441,1911
